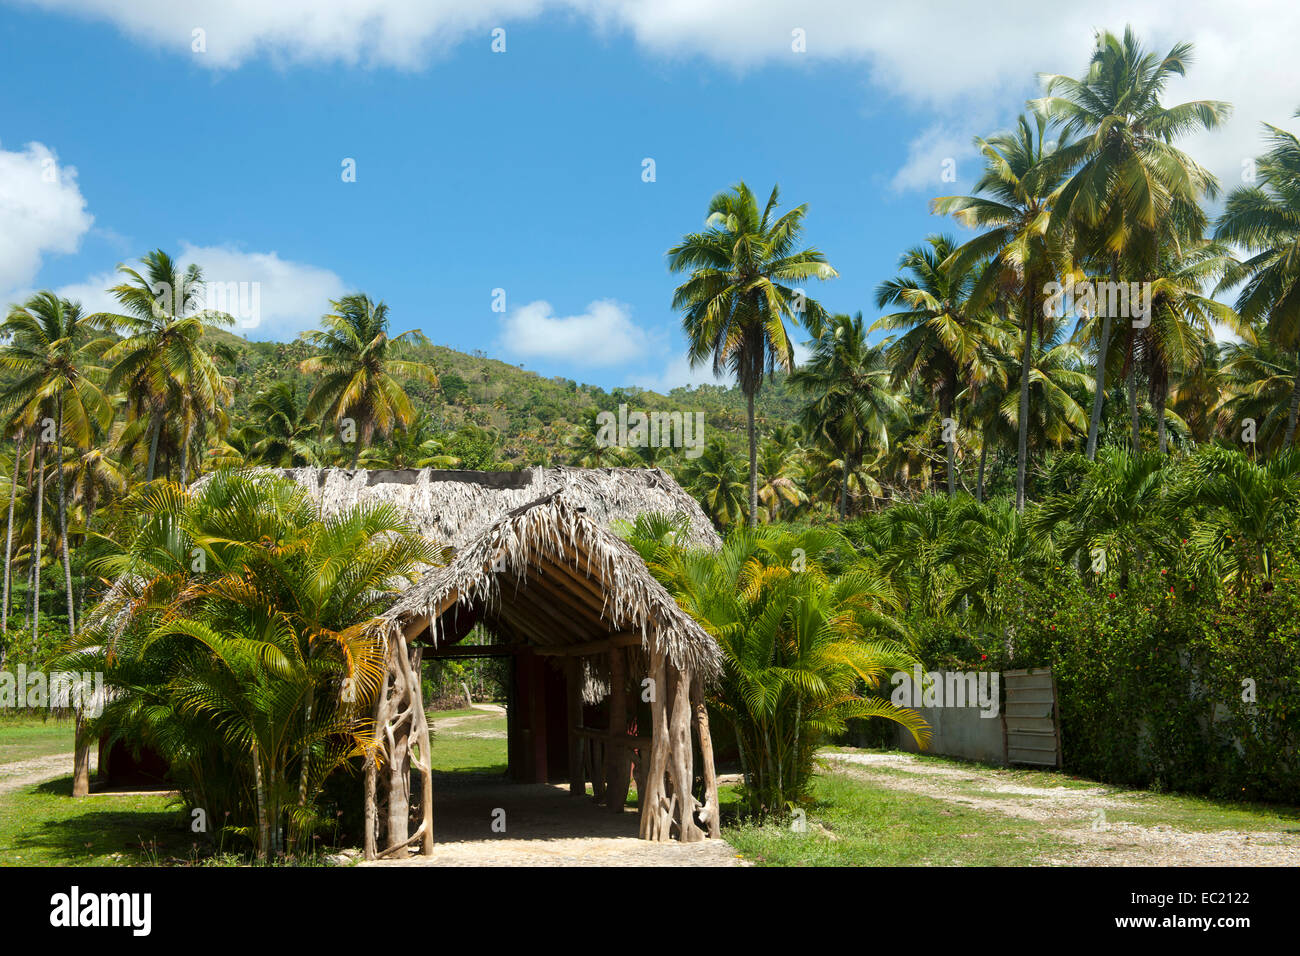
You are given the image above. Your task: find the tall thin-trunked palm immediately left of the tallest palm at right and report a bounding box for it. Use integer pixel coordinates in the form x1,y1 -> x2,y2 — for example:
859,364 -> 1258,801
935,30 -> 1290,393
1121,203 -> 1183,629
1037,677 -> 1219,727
931,113 -> 1069,511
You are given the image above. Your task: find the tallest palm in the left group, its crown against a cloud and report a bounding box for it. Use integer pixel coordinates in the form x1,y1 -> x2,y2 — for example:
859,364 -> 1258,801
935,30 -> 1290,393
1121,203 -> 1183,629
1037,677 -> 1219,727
88,248 -> 234,483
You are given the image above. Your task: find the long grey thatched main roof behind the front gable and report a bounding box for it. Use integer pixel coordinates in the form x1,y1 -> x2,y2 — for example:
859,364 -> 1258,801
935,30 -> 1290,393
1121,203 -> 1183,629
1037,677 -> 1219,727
257,468 -> 722,550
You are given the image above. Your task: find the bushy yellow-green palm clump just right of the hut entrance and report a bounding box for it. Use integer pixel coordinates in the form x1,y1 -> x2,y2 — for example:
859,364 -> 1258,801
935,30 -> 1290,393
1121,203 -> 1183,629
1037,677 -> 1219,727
631,528 -> 930,818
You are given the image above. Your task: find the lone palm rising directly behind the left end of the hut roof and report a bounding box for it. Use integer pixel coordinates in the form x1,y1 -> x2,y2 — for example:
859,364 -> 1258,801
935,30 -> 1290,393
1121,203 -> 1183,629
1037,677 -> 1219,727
299,293 -> 438,468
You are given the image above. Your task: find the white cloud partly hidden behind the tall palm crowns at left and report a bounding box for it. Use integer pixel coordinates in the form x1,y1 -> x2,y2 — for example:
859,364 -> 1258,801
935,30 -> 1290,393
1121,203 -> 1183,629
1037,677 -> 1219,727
42,242 -> 346,341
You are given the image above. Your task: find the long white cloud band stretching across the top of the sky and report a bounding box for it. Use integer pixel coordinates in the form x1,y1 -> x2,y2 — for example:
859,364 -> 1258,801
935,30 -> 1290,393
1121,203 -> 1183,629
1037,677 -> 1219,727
26,0 -> 1300,200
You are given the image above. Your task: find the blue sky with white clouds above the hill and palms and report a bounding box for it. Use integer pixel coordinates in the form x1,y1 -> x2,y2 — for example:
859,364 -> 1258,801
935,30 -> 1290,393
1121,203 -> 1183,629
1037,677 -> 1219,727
0,0 -> 1300,389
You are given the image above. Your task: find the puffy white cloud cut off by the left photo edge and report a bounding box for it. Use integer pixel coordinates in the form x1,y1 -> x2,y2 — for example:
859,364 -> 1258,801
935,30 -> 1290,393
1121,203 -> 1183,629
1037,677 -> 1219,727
0,143 -> 95,302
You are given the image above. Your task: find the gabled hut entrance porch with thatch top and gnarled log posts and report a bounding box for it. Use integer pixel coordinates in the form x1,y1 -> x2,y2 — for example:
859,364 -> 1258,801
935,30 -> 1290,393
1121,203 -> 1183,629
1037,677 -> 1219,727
365,494 -> 720,858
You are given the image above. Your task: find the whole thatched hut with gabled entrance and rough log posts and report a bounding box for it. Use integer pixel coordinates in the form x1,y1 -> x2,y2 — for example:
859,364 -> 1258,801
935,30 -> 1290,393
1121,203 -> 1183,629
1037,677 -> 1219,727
267,468 -> 722,858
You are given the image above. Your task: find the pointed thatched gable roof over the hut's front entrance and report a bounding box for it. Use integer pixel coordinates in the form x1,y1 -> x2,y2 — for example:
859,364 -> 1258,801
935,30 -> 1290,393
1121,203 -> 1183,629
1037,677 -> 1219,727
381,490 -> 722,680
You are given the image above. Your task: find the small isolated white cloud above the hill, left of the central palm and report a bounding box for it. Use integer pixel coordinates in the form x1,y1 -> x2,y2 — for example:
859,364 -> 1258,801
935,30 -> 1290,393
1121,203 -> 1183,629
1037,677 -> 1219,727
498,299 -> 662,368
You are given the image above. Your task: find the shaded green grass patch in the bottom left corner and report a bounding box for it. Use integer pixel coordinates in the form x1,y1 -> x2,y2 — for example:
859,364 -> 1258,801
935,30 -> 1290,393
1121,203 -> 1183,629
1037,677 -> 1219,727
0,777 -> 195,866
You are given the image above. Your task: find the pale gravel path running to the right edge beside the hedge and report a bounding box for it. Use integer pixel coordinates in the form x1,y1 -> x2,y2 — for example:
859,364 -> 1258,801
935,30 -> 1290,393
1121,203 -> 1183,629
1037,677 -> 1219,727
820,752 -> 1300,866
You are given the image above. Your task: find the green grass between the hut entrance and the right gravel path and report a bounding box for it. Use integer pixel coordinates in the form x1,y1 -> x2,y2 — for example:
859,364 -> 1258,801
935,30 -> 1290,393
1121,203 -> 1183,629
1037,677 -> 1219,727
720,773 -> 1073,866
